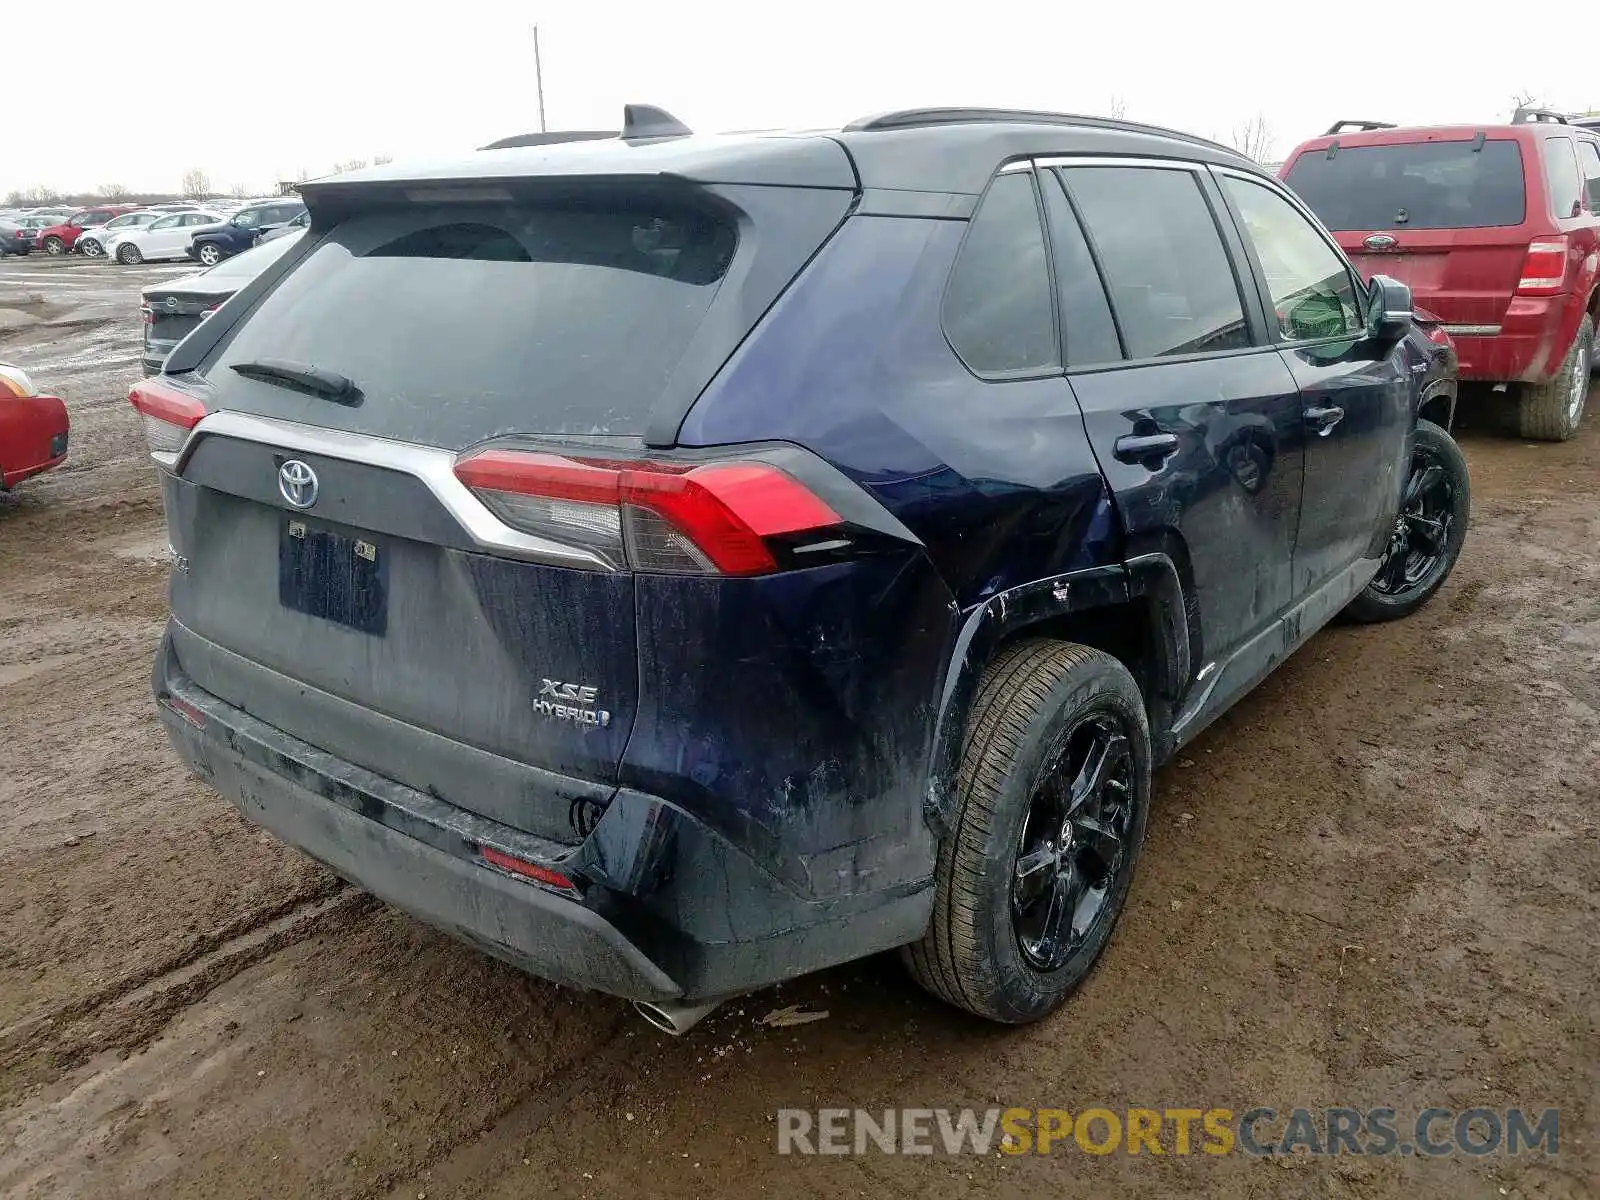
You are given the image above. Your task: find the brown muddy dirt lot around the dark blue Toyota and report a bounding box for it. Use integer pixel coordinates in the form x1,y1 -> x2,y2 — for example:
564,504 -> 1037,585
0,259 -> 1600,1200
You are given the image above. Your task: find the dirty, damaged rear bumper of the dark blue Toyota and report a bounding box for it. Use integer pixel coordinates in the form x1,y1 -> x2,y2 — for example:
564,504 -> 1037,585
154,638 -> 933,1002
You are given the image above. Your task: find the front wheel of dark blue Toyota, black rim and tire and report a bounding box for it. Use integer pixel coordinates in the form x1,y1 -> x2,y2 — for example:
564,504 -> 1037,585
1344,419 -> 1465,622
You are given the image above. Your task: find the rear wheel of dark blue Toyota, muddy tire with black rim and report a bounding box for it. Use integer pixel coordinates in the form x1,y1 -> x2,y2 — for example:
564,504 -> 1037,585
902,638 -> 1150,1024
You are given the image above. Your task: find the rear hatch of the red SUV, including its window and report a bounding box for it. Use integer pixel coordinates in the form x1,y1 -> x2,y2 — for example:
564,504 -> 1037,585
1283,128 -> 1549,334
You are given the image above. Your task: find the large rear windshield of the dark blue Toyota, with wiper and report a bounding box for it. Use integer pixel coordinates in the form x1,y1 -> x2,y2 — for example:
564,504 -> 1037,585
206,200 -> 734,445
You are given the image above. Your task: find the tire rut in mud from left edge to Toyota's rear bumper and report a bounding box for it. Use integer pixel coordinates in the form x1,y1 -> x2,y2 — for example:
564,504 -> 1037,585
0,877 -> 363,1093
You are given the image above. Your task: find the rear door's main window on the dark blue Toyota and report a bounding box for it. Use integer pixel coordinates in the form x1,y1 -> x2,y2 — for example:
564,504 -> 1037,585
1061,166 -> 1251,358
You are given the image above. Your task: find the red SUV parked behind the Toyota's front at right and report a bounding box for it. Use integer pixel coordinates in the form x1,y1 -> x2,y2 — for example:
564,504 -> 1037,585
1282,109 -> 1600,442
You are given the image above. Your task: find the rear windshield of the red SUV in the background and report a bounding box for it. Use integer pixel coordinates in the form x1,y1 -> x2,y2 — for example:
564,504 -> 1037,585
1286,138 -> 1523,229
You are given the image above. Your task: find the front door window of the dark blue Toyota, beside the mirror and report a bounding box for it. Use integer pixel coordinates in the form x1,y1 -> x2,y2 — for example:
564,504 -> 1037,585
1222,174 -> 1362,342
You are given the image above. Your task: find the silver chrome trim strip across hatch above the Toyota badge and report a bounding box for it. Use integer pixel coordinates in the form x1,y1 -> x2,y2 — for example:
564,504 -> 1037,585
180,413 -> 616,573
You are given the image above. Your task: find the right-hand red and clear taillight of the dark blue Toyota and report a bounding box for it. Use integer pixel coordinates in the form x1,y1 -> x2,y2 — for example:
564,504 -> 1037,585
456,450 -> 840,574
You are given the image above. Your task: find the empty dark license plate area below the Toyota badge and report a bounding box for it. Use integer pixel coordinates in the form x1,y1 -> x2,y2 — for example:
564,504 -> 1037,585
278,518 -> 389,637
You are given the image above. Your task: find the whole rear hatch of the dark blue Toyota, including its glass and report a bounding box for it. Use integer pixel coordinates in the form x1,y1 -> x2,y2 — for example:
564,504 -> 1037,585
144,164 -> 853,842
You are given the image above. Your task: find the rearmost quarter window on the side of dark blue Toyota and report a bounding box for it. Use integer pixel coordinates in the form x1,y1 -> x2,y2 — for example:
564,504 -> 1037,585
944,171 -> 1059,374
